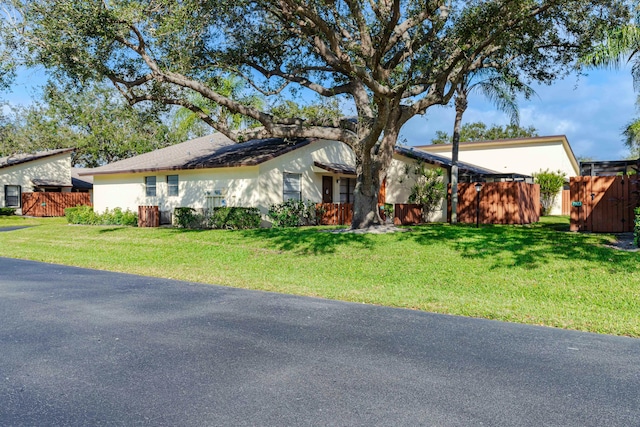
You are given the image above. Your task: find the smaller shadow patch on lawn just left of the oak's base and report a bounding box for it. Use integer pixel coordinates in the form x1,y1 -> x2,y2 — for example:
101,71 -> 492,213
237,227 -> 375,255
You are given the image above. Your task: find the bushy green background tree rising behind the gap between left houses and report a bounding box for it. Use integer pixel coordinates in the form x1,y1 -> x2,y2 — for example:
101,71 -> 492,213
0,84 -> 182,167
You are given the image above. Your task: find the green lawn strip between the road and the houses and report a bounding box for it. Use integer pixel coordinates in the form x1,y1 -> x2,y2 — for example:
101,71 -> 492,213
0,217 -> 640,337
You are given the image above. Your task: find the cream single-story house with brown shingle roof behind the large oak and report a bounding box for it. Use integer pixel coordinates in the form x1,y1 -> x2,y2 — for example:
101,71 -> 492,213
80,133 -> 536,223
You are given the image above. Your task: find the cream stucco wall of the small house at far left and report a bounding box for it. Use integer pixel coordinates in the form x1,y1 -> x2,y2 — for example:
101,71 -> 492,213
0,153 -> 71,213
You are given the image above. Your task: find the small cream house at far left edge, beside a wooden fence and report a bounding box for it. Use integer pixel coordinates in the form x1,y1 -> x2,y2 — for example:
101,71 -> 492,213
0,148 -> 73,214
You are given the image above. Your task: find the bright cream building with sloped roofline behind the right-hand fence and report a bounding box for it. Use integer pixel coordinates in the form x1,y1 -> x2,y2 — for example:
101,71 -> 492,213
415,135 -> 580,215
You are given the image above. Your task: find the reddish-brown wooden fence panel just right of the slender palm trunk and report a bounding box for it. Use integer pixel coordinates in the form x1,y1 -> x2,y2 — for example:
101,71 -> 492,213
448,182 -> 540,224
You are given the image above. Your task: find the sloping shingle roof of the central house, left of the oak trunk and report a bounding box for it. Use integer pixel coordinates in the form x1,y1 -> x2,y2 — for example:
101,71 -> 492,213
80,134 -> 311,175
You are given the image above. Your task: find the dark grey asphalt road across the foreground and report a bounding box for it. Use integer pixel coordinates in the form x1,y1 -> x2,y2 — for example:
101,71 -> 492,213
0,258 -> 640,427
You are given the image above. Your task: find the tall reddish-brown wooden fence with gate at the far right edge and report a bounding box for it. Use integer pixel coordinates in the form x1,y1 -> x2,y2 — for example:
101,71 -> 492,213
569,176 -> 640,233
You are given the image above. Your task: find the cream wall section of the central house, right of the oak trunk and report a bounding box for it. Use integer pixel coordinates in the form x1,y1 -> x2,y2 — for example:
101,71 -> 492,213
386,154 -> 449,222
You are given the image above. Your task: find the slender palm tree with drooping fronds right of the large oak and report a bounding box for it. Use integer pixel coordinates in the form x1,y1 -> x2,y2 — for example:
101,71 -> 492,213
451,68 -> 535,224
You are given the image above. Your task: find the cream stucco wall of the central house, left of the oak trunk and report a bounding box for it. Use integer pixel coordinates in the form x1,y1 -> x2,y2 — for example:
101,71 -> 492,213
93,141 -> 354,222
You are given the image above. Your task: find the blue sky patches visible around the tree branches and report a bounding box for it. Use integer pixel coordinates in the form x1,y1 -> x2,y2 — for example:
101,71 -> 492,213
0,68 -> 637,160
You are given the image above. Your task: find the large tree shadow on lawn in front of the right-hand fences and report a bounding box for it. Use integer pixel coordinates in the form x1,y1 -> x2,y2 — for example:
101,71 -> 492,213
400,223 -> 638,274
